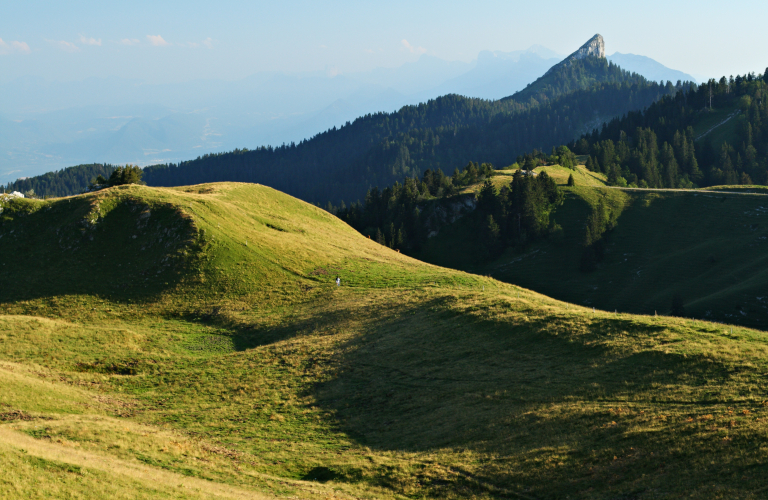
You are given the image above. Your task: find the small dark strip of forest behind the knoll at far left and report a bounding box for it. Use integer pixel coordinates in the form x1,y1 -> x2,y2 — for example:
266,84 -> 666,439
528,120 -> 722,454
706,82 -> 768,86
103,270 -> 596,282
4,163 -> 116,197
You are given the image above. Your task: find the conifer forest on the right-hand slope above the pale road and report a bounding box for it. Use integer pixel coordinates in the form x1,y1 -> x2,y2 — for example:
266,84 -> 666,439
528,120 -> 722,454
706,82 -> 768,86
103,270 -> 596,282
570,70 -> 768,188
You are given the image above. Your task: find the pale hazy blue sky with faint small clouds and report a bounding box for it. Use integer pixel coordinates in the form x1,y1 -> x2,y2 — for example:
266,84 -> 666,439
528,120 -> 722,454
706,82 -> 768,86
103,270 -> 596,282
0,0 -> 768,84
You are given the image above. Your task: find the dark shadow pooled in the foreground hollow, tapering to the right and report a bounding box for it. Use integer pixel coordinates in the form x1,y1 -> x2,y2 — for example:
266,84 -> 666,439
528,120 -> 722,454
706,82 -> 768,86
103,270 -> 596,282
318,301 -> 731,450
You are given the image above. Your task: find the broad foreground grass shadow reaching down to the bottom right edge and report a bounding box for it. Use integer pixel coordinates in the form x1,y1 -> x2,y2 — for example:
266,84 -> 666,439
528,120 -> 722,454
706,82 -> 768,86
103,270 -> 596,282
308,300 -> 764,498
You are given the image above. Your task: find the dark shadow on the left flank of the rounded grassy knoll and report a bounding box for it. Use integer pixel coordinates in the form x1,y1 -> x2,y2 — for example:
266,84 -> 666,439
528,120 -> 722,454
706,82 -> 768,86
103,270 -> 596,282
0,196 -> 194,304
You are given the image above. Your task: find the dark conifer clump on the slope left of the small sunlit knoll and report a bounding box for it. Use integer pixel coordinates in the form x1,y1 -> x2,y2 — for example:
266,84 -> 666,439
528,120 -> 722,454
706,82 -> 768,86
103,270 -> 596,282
338,161 -> 567,261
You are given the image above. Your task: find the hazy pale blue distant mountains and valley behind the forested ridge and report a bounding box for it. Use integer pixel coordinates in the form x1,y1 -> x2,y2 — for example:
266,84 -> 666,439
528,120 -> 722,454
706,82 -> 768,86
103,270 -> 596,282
0,39 -> 692,183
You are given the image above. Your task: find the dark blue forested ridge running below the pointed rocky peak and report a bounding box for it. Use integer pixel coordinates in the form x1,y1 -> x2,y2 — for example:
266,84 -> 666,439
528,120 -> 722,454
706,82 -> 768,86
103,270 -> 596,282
145,79 -> 677,204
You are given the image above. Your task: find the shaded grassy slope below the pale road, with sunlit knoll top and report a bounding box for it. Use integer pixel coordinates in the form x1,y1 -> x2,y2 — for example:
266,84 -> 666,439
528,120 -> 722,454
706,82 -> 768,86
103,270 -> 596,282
419,166 -> 768,328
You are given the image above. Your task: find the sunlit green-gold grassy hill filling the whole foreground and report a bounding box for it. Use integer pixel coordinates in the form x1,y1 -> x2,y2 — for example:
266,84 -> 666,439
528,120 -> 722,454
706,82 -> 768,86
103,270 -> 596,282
0,184 -> 768,498
